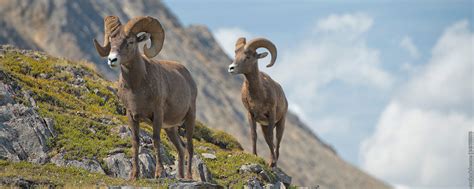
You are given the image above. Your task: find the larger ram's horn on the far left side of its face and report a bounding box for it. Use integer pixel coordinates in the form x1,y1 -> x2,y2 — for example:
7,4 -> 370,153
94,16 -> 122,57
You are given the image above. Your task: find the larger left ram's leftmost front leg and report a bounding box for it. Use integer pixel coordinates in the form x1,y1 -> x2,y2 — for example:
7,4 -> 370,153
128,113 -> 140,180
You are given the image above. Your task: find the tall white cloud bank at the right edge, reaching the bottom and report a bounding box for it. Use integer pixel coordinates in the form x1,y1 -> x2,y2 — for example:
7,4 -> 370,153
360,21 -> 474,188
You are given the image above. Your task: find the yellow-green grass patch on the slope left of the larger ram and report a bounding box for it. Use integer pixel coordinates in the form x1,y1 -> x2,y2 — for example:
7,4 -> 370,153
0,52 -> 129,161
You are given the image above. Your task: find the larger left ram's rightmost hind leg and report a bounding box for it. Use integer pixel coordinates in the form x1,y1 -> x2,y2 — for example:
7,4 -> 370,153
184,108 -> 196,179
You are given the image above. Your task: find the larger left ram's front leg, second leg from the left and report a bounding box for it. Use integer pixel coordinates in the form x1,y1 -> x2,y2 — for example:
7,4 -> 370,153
153,110 -> 167,178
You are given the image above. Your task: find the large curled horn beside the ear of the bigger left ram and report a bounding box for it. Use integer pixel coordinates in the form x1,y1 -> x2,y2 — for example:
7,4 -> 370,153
124,16 -> 165,58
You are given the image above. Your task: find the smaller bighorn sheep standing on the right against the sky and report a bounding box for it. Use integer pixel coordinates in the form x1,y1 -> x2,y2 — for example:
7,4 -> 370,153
228,38 -> 288,167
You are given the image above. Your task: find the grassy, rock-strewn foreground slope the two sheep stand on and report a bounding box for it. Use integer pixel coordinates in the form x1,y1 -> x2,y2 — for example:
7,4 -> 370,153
0,46 -> 291,188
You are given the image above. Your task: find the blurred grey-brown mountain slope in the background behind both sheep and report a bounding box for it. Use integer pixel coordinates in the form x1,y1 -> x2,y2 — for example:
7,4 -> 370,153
0,0 -> 388,188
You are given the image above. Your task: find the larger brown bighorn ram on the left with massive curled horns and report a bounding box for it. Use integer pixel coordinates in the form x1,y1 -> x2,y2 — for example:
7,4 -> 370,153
94,16 -> 197,179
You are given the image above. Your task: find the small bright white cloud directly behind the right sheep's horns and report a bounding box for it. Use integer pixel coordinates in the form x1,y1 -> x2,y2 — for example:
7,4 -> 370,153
214,27 -> 253,57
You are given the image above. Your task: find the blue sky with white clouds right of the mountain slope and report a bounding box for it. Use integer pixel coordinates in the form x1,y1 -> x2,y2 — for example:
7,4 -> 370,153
165,0 -> 474,188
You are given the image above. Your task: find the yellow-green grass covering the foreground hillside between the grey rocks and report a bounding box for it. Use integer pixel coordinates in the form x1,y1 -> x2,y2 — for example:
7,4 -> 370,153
0,46 -> 282,186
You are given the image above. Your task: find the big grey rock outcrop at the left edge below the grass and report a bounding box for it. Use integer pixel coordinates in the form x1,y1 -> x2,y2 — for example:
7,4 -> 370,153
0,88 -> 55,164
